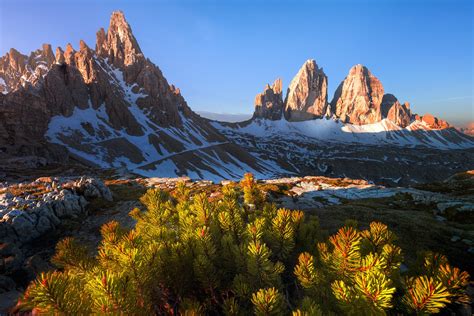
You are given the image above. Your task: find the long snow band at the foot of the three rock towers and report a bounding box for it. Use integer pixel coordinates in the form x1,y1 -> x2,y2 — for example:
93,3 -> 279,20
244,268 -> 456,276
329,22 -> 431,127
212,118 -> 474,149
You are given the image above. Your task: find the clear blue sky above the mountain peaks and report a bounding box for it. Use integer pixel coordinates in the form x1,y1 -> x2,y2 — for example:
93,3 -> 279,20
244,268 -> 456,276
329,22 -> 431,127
0,0 -> 474,124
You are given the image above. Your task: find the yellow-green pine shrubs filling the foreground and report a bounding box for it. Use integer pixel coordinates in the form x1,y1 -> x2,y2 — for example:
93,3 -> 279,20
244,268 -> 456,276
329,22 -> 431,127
22,174 -> 469,316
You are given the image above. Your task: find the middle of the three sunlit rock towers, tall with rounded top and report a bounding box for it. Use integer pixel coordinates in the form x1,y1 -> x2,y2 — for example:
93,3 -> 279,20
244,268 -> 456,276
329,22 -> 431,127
285,59 -> 330,121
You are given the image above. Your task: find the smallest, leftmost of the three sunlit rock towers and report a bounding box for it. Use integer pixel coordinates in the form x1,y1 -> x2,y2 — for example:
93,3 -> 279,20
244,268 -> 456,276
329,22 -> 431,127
253,79 -> 283,121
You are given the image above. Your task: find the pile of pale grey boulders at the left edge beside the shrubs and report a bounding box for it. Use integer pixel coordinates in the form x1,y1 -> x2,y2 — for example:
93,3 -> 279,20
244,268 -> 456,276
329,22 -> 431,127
0,178 -> 113,273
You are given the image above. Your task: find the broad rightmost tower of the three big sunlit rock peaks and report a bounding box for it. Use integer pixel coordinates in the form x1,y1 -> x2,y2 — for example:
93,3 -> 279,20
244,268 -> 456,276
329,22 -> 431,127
331,65 -> 384,125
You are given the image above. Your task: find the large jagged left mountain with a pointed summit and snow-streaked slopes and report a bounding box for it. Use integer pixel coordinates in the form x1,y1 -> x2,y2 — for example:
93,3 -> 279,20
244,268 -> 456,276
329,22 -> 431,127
0,11 -> 274,177
